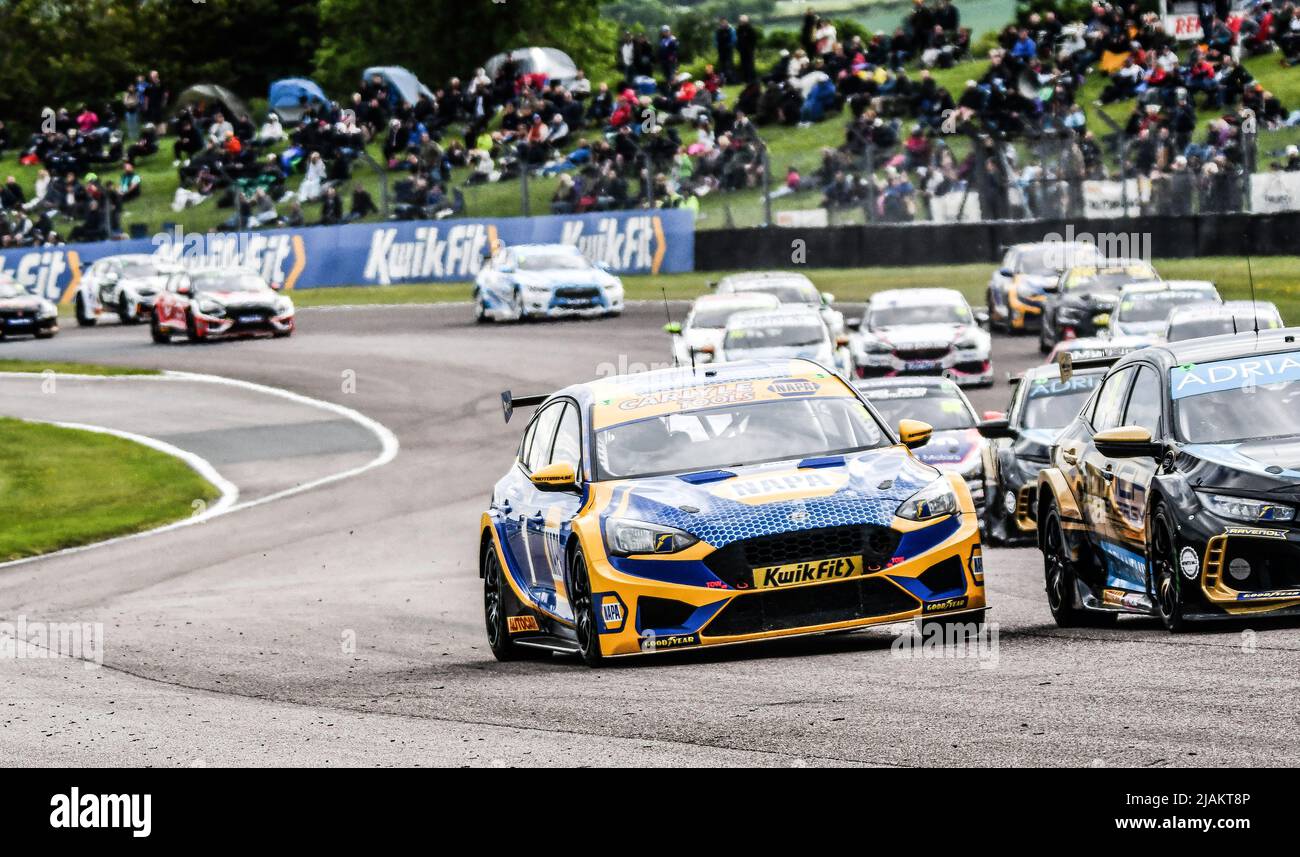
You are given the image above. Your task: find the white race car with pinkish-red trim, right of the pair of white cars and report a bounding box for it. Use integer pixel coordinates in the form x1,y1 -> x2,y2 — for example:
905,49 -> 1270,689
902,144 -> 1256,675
849,289 -> 993,386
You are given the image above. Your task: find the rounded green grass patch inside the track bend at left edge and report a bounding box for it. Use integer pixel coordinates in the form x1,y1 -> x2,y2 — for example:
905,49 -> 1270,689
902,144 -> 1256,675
0,417 -> 220,562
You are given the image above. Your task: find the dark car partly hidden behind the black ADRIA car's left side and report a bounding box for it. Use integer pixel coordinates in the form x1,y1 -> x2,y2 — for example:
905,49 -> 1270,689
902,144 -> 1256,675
978,356 -> 1119,545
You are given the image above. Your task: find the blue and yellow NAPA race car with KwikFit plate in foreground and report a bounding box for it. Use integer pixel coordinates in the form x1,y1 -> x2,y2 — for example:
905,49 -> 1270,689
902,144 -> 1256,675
480,360 -> 985,666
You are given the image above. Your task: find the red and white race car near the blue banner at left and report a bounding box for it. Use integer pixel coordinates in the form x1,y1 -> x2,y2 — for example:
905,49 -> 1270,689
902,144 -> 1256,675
150,268 -> 294,345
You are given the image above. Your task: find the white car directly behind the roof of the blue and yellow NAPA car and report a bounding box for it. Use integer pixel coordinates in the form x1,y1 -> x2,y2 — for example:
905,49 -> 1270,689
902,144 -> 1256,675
718,306 -> 853,377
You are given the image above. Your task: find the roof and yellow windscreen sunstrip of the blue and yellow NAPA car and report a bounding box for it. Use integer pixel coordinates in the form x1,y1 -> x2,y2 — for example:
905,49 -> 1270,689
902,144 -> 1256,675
582,359 -> 853,430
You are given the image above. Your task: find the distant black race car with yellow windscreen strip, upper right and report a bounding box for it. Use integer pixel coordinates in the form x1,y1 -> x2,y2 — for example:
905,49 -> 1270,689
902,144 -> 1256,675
1039,259 -> 1160,354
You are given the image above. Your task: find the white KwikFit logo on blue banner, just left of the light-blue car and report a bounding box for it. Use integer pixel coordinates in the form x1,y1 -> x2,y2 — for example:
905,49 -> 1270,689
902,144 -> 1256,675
361,224 -> 493,286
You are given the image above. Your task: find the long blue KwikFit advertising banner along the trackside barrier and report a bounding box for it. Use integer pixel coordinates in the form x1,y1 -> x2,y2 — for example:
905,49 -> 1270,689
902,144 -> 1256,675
0,209 -> 696,302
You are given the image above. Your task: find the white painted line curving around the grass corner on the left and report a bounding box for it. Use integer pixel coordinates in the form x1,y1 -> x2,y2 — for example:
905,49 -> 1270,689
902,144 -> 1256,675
0,371 -> 400,570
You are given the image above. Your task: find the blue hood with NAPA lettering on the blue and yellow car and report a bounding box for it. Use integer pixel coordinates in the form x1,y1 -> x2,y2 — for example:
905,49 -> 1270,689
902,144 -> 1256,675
607,446 -> 939,547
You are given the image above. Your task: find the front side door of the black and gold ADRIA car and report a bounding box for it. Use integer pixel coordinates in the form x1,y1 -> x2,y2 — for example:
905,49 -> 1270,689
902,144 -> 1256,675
1106,364 -> 1165,593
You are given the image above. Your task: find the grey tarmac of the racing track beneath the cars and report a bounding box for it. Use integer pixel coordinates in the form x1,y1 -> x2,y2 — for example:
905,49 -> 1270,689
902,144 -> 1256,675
0,304 -> 1300,766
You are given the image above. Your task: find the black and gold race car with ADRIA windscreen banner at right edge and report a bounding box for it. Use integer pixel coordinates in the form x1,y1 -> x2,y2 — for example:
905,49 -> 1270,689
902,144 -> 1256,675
1034,328 -> 1300,631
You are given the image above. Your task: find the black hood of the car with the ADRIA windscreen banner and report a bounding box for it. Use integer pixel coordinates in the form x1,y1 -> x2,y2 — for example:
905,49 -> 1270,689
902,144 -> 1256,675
1180,436 -> 1300,498
